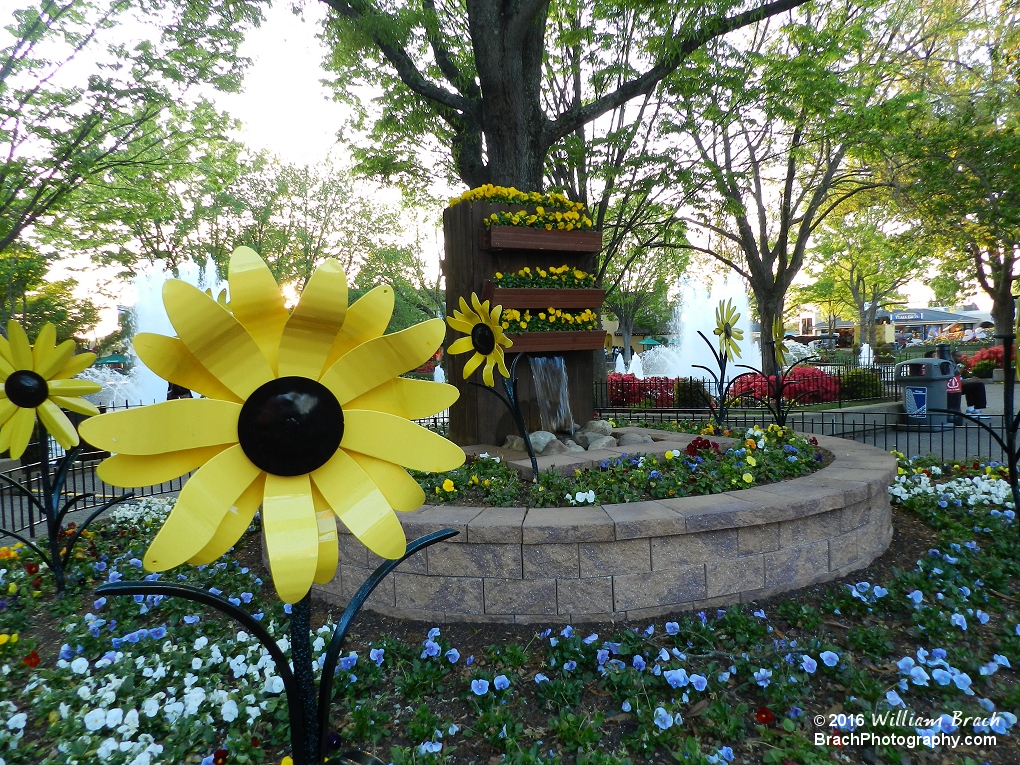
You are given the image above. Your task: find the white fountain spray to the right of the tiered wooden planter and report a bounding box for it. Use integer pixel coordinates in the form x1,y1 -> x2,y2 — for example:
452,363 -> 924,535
641,276 -> 760,379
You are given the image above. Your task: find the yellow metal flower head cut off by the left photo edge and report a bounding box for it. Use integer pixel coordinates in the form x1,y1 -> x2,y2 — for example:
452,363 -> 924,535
0,320 -> 103,459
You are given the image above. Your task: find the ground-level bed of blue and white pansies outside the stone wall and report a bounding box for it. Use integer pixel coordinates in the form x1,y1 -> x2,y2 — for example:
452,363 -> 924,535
0,459 -> 1020,765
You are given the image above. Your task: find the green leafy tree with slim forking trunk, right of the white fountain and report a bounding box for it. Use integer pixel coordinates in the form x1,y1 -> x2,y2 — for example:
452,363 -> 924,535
668,2 -> 936,372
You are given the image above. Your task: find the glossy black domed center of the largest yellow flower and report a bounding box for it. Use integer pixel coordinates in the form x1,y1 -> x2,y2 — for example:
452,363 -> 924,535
238,377 -> 344,475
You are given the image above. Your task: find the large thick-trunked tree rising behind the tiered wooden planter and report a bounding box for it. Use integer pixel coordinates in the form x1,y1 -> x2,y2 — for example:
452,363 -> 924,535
314,0 -> 805,191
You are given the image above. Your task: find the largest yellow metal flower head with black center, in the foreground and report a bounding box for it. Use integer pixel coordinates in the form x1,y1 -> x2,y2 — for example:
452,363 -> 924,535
82,247 -> 464,603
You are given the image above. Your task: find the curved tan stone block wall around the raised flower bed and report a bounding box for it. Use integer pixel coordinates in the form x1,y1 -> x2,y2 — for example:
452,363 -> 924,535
315,430 -> 897,623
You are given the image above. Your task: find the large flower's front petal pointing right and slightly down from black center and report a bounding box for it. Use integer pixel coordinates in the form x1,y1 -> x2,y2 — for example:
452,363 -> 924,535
344,409 -> 464,473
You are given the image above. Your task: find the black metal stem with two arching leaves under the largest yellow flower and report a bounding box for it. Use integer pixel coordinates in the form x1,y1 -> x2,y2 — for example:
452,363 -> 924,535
96,528 -> 459,765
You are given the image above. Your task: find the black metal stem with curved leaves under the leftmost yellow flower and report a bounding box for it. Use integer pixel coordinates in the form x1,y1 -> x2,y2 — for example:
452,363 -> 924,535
0,436 -> 135,598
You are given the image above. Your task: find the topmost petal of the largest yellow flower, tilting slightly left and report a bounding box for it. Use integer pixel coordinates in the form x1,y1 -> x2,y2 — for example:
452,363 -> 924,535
228,247 -> 290,375
